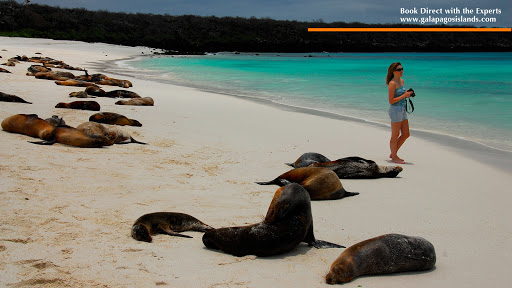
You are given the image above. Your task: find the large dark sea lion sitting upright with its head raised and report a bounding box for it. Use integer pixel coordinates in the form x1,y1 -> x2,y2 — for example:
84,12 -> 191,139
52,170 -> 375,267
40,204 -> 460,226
203,183 -> 344,257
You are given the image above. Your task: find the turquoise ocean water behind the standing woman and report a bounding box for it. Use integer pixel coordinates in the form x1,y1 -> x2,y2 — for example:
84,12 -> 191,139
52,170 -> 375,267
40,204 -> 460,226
117,53 -> 512,151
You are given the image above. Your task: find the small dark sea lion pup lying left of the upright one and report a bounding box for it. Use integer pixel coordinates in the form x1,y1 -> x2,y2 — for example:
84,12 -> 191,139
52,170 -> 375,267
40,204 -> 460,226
132,212 -> 213,242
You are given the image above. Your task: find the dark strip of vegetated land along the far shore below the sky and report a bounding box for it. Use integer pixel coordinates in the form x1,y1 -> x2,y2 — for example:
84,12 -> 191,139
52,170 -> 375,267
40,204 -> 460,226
0,1 -> 512,53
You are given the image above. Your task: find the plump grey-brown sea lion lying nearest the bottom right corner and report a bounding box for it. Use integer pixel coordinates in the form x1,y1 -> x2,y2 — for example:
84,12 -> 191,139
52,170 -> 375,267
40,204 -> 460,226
325,234 -> 436,284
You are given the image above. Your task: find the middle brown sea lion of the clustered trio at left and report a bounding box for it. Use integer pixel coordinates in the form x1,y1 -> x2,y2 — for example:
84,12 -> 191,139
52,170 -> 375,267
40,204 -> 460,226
29,125 -> 106,148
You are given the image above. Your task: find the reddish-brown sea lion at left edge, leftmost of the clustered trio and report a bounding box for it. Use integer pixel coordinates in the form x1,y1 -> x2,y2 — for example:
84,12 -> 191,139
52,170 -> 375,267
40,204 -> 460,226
2,114 -> 54,140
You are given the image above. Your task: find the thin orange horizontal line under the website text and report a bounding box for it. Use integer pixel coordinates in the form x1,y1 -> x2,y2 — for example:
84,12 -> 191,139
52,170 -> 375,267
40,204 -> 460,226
308,28 -> 512,32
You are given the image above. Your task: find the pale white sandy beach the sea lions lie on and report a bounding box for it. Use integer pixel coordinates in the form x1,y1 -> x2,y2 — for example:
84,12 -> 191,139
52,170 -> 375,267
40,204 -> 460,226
0,37 -> 512,288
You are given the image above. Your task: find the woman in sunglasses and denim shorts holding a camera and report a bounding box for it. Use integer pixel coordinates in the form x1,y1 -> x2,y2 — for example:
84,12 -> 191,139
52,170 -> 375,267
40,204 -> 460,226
386,62 -> 412,164
